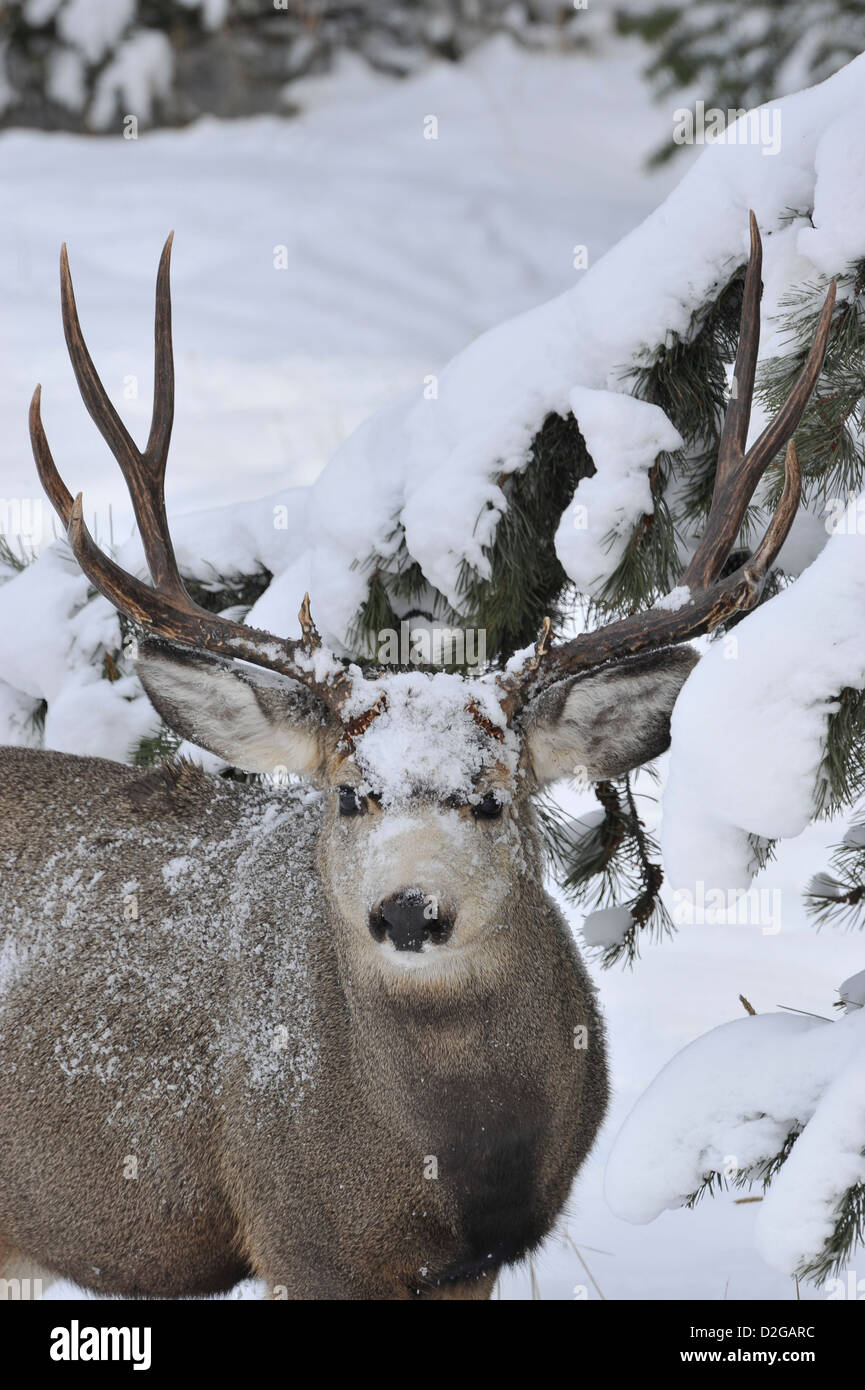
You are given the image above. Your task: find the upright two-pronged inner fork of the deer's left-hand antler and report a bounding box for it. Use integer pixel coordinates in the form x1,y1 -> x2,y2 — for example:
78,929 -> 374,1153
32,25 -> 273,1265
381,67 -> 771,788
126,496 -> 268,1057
60,232 -> 185,596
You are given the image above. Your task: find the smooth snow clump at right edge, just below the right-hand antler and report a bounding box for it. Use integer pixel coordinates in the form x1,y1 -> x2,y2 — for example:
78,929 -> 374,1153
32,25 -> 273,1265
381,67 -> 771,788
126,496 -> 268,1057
662,500 -> 865,890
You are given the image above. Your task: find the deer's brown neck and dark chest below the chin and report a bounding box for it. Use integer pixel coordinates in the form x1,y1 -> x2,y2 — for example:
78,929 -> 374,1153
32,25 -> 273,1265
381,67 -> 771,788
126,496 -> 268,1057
335,881 -> 577,1280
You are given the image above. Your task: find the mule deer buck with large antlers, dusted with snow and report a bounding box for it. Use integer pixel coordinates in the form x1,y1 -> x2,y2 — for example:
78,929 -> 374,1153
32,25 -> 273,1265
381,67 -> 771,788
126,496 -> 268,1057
0,218 -> 833,1298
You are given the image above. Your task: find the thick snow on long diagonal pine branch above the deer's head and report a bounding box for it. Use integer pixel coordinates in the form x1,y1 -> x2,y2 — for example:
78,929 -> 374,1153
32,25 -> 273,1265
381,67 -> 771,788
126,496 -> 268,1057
279,47 -> 865,642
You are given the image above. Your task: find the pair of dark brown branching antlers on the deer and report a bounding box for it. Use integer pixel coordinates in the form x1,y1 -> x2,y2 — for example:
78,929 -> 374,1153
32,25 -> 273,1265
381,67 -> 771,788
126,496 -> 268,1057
31,213 -> 836,741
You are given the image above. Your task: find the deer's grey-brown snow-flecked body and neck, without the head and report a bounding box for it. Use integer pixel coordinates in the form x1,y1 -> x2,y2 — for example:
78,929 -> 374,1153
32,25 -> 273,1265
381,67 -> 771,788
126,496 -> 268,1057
0,749 -> 605,1298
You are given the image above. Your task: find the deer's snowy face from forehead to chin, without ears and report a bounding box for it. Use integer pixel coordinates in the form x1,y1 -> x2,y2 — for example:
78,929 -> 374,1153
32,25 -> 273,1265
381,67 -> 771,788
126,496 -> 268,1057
321,673 -> 522,967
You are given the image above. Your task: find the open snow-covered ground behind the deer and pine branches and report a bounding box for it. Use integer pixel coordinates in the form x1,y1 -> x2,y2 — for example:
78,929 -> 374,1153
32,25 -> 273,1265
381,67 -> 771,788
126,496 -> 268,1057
0,32 -> 862,1298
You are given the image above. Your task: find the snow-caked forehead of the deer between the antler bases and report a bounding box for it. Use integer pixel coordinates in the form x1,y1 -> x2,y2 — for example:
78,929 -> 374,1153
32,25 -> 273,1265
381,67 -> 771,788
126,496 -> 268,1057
335,674 -> 519,805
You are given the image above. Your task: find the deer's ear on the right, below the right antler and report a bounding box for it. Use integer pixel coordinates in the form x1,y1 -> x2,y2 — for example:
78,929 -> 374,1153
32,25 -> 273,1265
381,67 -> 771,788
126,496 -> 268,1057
526,646 -> 700,787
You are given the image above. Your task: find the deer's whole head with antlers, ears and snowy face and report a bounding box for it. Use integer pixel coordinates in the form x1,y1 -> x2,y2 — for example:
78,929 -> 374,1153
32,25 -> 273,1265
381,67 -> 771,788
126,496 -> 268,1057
31,222 -> 834,972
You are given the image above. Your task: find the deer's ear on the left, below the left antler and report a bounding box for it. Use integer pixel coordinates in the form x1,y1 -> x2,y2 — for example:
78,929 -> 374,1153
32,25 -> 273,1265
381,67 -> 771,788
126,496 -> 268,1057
135,638 -> 328,777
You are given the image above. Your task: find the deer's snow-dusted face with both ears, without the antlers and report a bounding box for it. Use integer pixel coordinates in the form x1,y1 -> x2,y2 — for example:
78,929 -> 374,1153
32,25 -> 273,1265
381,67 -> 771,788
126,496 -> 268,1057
138,641 -> 695,970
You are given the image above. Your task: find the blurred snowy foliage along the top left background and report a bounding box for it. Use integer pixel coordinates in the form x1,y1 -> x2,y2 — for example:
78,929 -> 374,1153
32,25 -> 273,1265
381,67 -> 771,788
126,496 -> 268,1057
0,0 -> 583,131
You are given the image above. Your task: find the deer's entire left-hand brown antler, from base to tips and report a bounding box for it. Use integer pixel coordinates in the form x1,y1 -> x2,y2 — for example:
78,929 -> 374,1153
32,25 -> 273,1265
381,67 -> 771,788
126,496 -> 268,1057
31,234 -> 352,714
